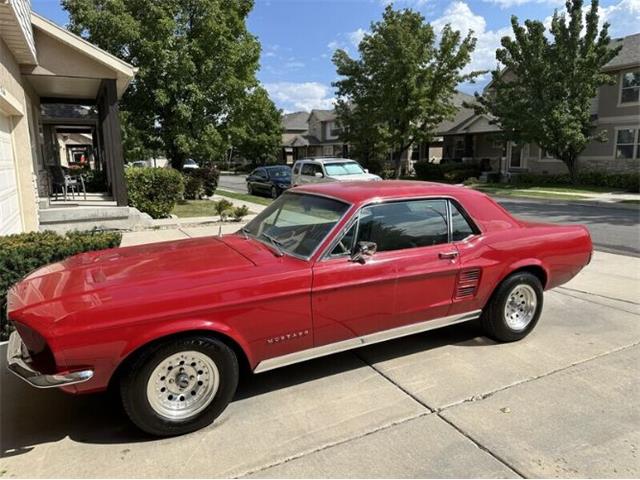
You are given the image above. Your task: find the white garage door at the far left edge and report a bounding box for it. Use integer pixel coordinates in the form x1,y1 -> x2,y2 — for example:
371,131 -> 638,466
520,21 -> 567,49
0,113 -> 22,235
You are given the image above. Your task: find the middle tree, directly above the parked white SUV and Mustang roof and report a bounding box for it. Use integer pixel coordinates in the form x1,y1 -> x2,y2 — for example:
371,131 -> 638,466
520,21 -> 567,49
333,5 -> 477,176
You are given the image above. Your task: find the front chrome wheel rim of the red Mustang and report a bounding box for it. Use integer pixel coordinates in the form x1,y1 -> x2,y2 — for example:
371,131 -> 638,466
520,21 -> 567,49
147,351 -> 220,420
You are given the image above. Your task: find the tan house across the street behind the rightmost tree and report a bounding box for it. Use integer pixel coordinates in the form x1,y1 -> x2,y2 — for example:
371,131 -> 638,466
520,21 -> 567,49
438,33 -> 640,175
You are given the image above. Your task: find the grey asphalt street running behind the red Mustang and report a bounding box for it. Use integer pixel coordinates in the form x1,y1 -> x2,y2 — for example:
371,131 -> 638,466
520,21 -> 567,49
220,175 -> 640,257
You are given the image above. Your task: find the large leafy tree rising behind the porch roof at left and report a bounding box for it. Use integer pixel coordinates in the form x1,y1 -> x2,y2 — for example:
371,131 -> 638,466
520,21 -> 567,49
62,0 -> 279,168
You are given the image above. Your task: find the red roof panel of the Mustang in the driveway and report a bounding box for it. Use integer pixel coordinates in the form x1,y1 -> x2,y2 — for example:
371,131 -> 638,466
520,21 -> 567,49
290,180 -> 484,204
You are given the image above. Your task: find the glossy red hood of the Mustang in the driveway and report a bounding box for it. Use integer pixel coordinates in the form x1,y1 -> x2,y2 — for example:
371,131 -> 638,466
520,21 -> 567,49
8,235 -> 275,312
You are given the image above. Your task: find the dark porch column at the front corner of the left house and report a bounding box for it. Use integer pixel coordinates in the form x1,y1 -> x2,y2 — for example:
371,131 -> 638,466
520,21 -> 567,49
97,79 -> 128,206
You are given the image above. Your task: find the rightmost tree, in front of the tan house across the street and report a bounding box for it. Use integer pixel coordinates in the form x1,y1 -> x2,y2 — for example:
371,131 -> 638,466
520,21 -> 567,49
476,0 -> 619,182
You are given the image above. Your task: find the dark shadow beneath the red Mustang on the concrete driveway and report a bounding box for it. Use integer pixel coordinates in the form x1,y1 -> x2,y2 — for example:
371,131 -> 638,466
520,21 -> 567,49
0,322 -> 492,457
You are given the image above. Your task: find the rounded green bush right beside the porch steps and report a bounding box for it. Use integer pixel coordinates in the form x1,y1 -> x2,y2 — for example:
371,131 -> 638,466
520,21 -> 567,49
125,168 -> 184,218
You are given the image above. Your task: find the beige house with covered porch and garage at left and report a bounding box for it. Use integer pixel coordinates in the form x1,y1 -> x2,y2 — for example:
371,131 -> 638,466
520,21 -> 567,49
0,0 -> 135,235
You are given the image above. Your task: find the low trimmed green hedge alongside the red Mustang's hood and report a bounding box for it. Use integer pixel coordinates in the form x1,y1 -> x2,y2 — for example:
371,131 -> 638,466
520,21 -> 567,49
0,231 -> 122,339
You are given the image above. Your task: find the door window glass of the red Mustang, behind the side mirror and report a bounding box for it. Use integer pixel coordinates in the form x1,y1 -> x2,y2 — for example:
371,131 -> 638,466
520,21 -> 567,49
358,200 -> 449,252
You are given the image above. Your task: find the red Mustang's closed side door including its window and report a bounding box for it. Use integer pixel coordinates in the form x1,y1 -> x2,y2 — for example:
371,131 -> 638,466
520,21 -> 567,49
312,199 -> 459,346
